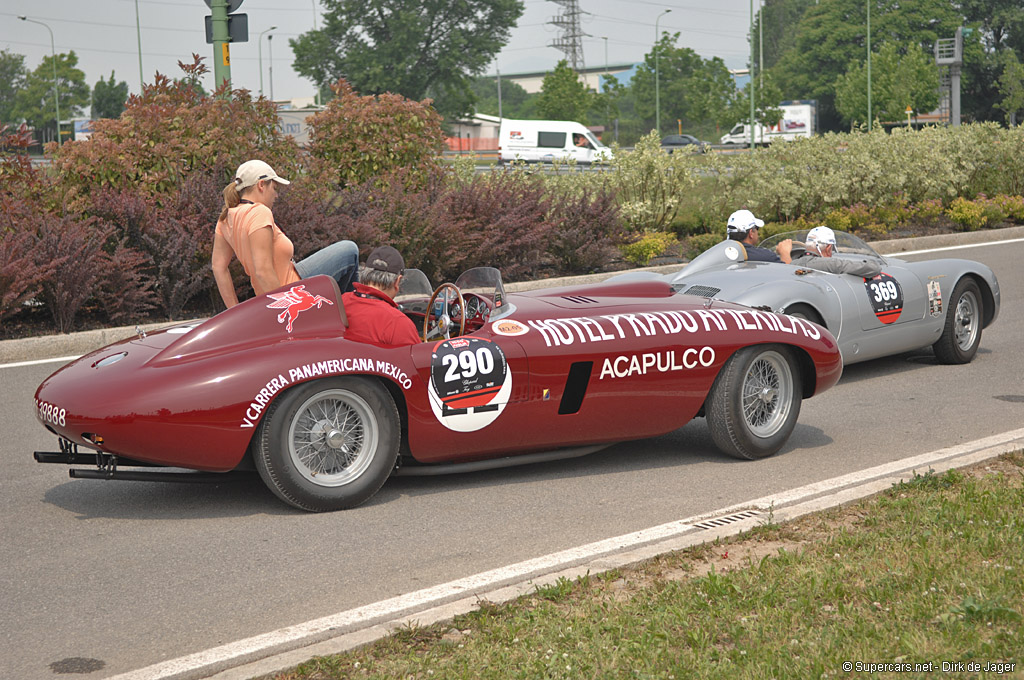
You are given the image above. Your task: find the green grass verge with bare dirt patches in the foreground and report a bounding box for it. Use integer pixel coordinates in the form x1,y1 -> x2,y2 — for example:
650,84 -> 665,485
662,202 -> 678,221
275,453 -> 1024,680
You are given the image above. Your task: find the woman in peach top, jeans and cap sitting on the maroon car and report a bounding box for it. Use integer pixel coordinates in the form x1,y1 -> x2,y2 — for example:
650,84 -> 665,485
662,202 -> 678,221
210,160 -> 359,307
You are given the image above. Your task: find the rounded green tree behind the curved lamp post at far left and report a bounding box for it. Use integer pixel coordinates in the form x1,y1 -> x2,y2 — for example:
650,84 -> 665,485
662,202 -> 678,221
13,51 -> 89,139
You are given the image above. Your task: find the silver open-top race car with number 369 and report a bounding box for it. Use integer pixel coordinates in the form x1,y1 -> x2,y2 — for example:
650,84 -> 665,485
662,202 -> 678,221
614,230 -> 999,364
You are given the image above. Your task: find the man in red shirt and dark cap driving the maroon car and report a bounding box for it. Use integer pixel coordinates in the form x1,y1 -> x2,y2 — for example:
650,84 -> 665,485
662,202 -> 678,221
341,246 -> 420,347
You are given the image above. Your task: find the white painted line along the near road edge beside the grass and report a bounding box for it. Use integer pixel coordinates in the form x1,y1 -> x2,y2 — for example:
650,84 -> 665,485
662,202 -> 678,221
103,428 -> 1024,680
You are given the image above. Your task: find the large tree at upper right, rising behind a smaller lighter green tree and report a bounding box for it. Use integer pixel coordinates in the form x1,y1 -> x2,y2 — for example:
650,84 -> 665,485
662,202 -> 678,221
772,0 -> 963,130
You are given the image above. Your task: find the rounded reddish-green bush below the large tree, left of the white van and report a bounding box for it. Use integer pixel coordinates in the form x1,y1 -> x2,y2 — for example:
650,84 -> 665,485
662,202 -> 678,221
308,79 -> 444,186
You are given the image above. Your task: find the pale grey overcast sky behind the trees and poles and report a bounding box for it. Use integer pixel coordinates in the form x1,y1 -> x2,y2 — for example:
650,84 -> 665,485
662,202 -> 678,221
0,0 -> 757,107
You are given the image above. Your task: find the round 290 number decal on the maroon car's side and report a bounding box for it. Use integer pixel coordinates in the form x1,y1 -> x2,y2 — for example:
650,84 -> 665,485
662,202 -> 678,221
427,338 -> 512,432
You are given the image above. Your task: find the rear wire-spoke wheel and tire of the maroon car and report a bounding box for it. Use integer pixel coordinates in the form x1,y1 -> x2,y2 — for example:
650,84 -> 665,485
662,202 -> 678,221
253,376 -> 401,512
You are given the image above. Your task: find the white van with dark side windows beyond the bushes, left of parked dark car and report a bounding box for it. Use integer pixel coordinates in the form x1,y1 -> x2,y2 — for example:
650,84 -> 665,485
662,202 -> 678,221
498,119 -> 611,165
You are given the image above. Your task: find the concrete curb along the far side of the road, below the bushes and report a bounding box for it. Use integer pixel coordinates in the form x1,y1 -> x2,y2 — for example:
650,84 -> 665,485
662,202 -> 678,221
0,226 -> 1024,364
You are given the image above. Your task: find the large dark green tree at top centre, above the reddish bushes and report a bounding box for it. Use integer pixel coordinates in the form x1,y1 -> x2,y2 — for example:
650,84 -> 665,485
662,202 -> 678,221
289,0 -> 523,115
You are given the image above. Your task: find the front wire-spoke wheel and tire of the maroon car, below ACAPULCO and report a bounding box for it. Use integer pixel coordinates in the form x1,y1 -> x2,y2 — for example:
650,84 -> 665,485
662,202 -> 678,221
705,345 -> 803,460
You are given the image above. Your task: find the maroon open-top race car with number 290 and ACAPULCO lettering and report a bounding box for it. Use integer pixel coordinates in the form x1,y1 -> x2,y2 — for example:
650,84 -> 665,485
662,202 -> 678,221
35,267 -> 843,511
